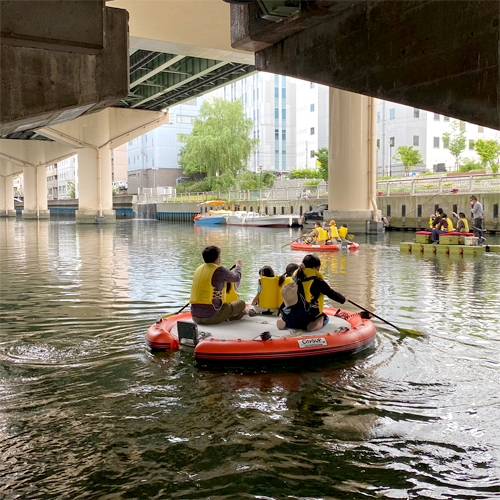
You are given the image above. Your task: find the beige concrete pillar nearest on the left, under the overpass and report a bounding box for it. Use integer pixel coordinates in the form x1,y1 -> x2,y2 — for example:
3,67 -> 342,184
76,146 -> 116,224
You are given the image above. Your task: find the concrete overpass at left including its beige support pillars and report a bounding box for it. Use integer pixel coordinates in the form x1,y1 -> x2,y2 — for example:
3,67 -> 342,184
0,0 -> 255,222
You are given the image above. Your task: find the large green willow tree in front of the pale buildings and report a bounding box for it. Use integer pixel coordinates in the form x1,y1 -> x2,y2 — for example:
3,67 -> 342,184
181,99 -> 259,189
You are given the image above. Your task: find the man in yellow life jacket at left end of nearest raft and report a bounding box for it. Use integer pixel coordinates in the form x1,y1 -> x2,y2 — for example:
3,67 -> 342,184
190,246 -> 246,325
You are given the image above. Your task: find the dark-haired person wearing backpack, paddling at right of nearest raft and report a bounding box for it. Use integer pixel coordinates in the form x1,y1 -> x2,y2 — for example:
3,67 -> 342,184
276,254 -> 347,332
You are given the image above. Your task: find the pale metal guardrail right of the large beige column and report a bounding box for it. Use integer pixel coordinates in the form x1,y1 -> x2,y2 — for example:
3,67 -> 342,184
377,174 -> 500,196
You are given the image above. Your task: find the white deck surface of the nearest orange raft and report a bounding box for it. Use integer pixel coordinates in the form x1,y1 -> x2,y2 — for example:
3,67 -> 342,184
172,314 -> 352,341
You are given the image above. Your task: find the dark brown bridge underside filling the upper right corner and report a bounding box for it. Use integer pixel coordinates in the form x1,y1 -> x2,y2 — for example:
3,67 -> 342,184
230,0 -> 500,129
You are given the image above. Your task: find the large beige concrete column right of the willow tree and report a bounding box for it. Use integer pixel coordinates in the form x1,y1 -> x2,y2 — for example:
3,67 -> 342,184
324,88 -> 382,232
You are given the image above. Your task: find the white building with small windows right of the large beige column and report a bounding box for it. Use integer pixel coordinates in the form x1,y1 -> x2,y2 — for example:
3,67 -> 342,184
377,100 -> 500,177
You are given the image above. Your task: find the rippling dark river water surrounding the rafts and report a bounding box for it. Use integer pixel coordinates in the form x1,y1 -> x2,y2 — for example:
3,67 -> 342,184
0,219 -> 500,500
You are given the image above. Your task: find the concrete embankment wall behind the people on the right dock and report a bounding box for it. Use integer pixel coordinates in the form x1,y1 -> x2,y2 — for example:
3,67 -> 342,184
377,193 -> 500,232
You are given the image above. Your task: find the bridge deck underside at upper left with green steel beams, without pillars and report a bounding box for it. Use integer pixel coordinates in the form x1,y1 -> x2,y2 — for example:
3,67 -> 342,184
0,0 -> 255,139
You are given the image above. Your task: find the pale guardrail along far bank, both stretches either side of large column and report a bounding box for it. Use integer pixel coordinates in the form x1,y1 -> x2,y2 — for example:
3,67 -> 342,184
134,174 -> 500,203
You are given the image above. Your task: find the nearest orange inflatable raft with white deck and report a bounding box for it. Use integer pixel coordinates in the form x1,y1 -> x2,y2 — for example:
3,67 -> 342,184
146,307 -> 376,363
